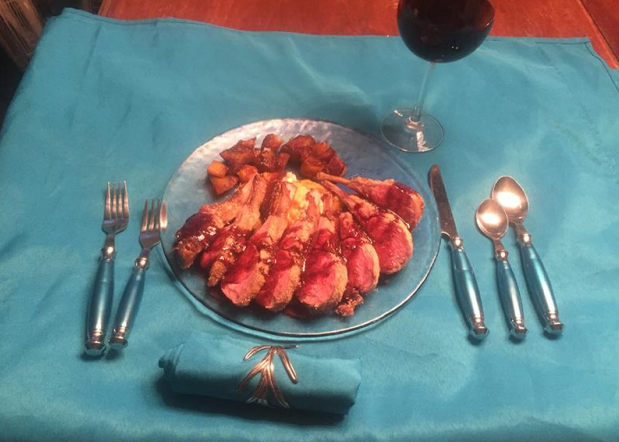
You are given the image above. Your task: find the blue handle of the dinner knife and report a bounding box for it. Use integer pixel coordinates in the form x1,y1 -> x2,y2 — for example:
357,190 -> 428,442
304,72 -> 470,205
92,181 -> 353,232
450,237 -> 488,341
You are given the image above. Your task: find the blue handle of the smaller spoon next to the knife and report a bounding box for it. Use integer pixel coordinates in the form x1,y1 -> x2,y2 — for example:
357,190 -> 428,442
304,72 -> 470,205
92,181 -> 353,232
496,258 -> 527,339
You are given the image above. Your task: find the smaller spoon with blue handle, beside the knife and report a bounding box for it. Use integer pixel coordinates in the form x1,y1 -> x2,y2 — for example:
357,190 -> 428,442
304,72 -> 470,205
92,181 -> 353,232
475,199 -> 527,340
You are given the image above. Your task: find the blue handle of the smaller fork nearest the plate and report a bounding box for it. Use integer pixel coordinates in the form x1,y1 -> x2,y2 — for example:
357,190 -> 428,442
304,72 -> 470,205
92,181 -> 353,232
110,265 -> 146,350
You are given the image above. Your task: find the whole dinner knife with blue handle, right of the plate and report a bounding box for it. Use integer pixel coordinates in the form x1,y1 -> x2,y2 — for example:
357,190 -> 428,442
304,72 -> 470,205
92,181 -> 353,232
428,164 -> 488,341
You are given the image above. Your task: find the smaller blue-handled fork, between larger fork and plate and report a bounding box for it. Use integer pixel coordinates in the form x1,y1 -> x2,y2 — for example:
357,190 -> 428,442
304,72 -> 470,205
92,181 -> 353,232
110,199 -> 168,350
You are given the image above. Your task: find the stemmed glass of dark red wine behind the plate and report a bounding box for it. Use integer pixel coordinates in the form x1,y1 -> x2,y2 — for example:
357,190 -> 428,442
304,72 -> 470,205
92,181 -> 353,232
381,0 -> 494,152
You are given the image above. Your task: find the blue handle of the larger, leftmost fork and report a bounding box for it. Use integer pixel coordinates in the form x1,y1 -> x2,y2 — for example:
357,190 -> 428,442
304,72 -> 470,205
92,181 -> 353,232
85,257 -> 114,356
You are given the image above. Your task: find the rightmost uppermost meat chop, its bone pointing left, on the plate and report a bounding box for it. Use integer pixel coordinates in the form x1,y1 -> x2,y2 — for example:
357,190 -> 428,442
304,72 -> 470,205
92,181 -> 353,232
318,173 -> 425,230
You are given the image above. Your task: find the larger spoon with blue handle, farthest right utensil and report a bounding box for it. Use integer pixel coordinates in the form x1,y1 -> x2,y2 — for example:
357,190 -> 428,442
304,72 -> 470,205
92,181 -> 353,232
492,176 -> 563,336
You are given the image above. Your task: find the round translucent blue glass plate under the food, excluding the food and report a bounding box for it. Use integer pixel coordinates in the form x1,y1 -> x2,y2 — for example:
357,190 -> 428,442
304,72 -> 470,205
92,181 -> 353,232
162,119 -> 440,338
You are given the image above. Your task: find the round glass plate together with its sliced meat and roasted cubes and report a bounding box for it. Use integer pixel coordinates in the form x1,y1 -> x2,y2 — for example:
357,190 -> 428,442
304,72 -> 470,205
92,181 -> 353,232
162,119 -> 440,338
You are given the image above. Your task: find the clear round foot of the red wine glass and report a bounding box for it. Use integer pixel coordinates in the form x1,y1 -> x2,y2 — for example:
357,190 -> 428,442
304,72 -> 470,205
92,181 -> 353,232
380,109 -> 443,153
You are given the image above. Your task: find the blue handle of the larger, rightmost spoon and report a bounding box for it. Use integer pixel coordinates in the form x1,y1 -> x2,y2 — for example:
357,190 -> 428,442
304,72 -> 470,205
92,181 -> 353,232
519,241 -> 563,335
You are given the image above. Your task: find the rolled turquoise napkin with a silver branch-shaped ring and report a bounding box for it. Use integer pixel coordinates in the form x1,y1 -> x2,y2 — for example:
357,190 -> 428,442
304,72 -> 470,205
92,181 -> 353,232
159,332 -> 361,414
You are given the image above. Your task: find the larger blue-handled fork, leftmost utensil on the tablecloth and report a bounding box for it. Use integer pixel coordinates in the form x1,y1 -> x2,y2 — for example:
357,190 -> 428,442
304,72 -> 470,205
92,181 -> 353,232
85,181 -> 129,356
